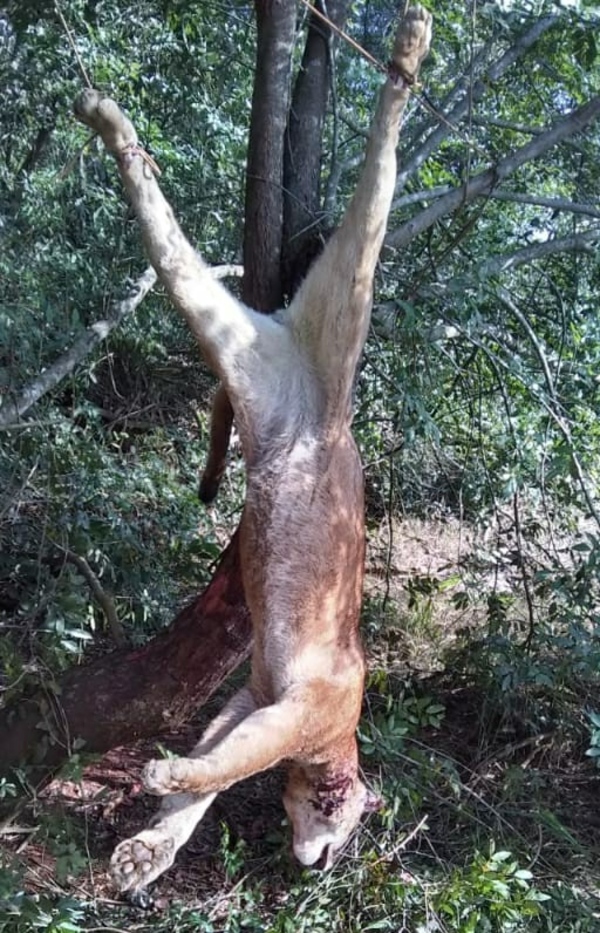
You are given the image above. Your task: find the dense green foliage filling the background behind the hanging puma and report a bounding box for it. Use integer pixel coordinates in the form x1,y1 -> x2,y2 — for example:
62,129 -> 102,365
0,0 -> 600,933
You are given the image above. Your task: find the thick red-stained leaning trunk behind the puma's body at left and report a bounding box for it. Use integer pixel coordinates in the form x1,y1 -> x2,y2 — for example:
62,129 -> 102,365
0,533 -> 252,776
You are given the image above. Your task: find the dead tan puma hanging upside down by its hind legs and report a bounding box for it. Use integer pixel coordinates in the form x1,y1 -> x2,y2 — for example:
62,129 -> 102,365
75,7 -> 431,890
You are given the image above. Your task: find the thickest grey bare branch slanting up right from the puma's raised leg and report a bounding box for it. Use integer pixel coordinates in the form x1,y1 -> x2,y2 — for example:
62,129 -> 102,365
386,97 -> 600,248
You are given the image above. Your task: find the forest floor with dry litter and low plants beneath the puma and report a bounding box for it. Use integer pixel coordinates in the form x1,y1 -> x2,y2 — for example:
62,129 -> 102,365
0,520 -> 600,933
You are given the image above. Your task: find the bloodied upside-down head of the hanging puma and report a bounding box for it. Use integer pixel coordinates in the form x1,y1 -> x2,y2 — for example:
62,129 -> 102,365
283,768 -> 382,869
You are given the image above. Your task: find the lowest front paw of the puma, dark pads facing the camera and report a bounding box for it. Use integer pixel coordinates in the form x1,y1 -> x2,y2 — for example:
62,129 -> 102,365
110,829 -> 177,891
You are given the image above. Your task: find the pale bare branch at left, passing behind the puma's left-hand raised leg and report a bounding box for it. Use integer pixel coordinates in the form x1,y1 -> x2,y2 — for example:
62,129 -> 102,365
0,265 -> 243,430
